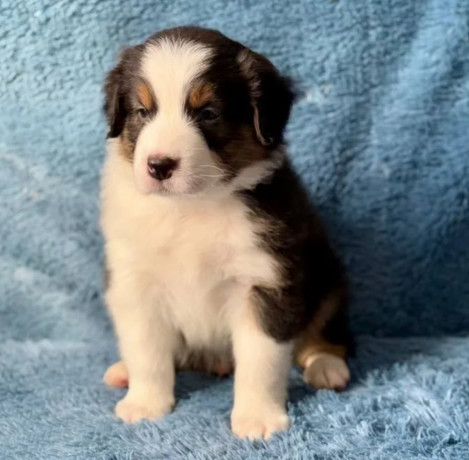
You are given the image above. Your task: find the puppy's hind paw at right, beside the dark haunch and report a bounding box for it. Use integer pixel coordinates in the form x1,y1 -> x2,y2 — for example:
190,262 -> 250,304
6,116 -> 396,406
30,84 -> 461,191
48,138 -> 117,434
303,354 -> 350,390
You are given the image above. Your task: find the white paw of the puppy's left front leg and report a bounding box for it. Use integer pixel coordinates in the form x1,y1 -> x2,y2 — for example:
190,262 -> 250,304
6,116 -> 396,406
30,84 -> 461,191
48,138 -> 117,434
115,393 -> 174,423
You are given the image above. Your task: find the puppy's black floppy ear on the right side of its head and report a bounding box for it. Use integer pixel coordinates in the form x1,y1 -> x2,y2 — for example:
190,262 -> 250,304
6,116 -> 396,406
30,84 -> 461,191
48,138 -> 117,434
238,49 -> 295,148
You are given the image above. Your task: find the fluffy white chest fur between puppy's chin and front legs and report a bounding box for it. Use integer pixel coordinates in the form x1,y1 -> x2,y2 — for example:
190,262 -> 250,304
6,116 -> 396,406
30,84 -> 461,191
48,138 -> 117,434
101,147 -> 275,351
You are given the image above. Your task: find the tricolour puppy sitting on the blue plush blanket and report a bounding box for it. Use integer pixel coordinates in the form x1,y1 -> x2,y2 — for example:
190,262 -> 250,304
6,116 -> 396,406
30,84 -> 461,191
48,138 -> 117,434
101,27 -> 350,439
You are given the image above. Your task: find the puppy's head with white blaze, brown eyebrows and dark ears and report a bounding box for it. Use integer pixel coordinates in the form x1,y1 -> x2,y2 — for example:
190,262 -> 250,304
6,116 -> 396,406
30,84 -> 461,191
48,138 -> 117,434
105,27 -> 293,195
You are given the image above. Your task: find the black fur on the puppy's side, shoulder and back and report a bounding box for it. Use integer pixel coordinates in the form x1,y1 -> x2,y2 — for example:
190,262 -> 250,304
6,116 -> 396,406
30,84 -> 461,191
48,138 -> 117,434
240,162 -> 348,344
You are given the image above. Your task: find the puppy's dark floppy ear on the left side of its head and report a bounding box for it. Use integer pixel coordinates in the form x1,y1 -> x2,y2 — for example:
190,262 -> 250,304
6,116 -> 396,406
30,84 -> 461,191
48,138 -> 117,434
104,46 -> 142,137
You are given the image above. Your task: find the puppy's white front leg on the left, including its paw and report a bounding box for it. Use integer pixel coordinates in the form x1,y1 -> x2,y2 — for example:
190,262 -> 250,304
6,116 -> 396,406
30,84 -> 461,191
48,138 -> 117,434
106,276 -> 176,423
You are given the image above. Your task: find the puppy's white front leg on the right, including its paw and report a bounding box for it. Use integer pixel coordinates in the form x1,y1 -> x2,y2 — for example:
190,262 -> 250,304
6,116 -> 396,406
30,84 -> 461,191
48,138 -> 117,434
231,292 -> 293,439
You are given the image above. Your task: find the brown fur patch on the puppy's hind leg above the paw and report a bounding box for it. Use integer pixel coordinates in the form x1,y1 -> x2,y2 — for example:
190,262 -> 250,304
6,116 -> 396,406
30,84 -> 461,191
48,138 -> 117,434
295,290 -> 348,368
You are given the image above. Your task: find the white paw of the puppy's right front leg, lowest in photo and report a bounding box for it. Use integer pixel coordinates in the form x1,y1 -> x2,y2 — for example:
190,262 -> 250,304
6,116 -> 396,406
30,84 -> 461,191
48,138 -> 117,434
231,405 -> 290,440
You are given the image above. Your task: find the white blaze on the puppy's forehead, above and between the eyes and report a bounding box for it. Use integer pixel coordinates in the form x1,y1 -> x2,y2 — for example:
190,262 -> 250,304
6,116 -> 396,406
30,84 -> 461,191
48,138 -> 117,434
142,39 -> 212,115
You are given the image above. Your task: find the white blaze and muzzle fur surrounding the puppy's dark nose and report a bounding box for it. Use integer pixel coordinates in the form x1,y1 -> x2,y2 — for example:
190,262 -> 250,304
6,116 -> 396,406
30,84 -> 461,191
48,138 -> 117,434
134,38 -> 215,194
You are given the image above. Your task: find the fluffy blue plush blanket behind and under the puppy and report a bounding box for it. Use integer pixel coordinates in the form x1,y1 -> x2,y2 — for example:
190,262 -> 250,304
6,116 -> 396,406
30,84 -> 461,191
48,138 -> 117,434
0,0 -> 469,460
